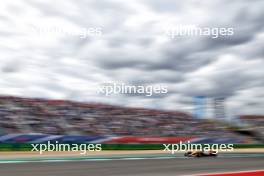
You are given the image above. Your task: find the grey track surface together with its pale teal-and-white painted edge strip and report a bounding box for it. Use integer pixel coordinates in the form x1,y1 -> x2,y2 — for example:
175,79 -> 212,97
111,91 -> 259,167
0,153 -> 264,176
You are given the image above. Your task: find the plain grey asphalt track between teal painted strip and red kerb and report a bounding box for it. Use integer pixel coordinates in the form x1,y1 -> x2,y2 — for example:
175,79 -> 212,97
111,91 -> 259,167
0,157 -> 264,176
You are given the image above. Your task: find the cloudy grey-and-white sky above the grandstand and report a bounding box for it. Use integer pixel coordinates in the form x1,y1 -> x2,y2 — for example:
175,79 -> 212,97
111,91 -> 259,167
0,0 -> 264,115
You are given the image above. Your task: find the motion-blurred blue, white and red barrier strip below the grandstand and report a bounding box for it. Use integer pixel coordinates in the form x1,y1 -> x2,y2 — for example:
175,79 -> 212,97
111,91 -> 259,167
0,134 -> 248,144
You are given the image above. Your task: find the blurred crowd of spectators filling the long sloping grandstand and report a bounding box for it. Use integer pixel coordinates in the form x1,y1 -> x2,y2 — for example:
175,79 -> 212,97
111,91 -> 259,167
0,97 -> 243,137
